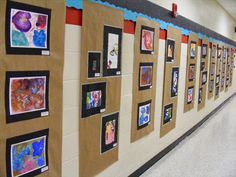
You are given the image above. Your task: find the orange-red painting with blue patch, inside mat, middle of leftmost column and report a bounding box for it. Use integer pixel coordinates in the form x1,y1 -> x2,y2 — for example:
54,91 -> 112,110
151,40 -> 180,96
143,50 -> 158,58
9,76 -> 46,115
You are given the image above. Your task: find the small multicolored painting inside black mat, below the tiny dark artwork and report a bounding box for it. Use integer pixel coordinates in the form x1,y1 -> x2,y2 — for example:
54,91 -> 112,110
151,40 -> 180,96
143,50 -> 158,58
86,90 -> 102,109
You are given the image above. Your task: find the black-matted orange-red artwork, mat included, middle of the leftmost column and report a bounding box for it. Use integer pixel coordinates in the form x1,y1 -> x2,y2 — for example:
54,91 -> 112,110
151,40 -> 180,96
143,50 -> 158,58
5,71 -> 49,123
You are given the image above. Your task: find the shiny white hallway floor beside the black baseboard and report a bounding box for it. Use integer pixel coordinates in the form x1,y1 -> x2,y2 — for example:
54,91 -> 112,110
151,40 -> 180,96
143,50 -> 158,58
142,96 -> 236,177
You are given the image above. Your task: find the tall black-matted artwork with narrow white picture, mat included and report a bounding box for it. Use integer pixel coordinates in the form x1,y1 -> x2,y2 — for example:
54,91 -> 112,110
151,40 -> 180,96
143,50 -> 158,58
103,26 -> 122,76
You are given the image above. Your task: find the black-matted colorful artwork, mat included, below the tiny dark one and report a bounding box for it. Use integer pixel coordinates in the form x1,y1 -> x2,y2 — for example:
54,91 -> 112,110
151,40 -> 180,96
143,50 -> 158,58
82,82 -> 106,118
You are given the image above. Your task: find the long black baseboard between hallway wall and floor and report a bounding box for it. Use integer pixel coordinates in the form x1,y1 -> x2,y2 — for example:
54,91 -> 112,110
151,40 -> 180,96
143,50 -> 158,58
129,92 -> 236,177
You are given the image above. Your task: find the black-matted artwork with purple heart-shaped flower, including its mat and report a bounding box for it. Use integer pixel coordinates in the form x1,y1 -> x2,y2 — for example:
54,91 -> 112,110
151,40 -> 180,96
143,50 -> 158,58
5,1 -> 51,55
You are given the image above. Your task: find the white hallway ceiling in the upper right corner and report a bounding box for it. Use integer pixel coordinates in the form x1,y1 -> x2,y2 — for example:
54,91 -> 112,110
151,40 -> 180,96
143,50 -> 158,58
216,0 -> 236,21
